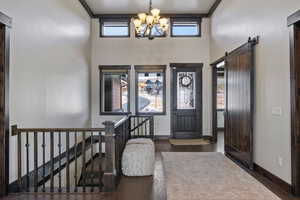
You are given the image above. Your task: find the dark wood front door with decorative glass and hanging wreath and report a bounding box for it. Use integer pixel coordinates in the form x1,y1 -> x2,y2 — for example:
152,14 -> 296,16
171,64 -> 203,138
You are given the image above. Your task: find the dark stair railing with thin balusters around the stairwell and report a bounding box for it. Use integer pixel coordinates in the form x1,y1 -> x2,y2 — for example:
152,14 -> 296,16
10,115 -> 154,193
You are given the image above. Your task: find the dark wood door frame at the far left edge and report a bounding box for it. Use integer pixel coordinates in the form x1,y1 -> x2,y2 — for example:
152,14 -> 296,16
0,12 -> 12,196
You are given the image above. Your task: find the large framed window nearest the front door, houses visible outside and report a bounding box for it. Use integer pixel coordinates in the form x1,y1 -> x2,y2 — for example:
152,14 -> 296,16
135,65 -> 166,115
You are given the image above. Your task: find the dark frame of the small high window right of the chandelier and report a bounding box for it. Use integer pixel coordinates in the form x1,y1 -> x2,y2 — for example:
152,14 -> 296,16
170,17 -> 202,38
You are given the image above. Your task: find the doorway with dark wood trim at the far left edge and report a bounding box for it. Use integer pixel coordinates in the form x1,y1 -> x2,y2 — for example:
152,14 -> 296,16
0,12 -> 11,196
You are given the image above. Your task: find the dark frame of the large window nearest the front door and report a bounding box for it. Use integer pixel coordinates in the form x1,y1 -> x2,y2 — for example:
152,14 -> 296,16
134,65 -> 167,115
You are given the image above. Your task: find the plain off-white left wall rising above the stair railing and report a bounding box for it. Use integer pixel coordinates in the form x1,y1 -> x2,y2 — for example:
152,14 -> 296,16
0,0 -> 90,182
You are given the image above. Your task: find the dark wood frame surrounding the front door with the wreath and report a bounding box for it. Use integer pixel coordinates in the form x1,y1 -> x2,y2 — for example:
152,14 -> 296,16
170,63 -> 204,138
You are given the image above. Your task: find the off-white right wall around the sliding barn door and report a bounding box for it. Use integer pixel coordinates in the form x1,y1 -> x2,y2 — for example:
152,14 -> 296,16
211,0 -> 300,183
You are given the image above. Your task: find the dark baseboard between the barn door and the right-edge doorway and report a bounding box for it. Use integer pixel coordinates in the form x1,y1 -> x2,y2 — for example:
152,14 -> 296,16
253,163 -> 292,194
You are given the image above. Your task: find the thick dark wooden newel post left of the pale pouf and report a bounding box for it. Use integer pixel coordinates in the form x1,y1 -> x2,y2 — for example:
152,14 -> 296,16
103,121 -> 117,191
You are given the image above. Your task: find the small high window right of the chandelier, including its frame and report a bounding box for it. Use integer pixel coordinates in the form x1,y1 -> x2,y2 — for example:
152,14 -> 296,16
171,18 -> 201,37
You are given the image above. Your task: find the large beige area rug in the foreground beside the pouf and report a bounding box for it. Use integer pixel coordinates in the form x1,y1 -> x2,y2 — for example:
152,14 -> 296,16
162,153 -> 280,200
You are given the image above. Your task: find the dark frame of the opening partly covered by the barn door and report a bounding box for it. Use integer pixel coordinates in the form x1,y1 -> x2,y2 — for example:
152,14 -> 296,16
210,56 -> 226,143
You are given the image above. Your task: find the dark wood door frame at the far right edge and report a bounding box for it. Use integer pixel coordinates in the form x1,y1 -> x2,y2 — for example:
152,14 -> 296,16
287,10 -> 300,196
